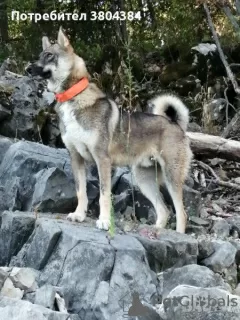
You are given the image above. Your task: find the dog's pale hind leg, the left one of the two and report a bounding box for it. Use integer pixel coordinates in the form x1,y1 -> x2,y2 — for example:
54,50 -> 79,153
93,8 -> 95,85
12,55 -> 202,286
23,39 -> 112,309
132,166 -> 169,228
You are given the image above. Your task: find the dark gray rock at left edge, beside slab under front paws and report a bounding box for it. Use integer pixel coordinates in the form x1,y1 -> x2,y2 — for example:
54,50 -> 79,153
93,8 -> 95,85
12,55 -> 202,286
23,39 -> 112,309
0,211 -> 35,266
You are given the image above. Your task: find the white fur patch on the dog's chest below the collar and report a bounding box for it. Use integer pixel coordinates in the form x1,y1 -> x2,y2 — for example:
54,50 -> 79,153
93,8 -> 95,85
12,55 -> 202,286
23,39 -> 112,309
59,103 -> 96,161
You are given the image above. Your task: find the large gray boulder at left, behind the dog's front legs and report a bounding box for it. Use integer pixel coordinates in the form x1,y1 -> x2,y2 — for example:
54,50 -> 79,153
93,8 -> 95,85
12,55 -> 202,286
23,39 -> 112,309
0,141 -> 99,213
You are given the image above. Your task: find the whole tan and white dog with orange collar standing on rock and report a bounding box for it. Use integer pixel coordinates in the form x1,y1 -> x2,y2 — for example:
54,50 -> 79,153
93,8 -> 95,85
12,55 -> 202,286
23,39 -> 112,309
28,28 -> 192,233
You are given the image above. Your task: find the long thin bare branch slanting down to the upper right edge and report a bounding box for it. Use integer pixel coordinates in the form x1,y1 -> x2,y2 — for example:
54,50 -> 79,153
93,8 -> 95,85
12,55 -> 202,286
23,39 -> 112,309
203,3 -> 240,94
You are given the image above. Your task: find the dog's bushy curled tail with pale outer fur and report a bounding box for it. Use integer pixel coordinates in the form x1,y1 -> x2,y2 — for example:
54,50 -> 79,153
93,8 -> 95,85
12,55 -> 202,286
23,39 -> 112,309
149,94 -> 189,131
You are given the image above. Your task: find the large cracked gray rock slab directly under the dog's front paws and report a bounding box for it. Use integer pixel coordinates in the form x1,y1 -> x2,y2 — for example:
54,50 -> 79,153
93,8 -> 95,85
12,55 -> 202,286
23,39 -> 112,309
8,216 -> 157,320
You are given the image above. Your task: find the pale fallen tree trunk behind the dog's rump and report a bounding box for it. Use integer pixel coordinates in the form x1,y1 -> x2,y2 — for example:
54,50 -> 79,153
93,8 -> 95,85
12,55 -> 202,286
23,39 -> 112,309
187,132 -> 240,162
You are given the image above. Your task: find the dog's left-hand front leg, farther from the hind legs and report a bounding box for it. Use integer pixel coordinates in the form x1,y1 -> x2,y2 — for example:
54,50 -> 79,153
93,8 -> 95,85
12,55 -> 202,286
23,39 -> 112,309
67,149 -> 88,222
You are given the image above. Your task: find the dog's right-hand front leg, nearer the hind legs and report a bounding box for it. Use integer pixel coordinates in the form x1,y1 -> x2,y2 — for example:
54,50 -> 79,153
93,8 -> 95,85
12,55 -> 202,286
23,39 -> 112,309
95,152 -> 111,230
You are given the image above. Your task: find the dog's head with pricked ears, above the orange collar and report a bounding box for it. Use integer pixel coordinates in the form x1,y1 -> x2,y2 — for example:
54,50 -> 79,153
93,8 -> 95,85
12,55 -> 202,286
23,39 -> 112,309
26,28 -> 89,93
